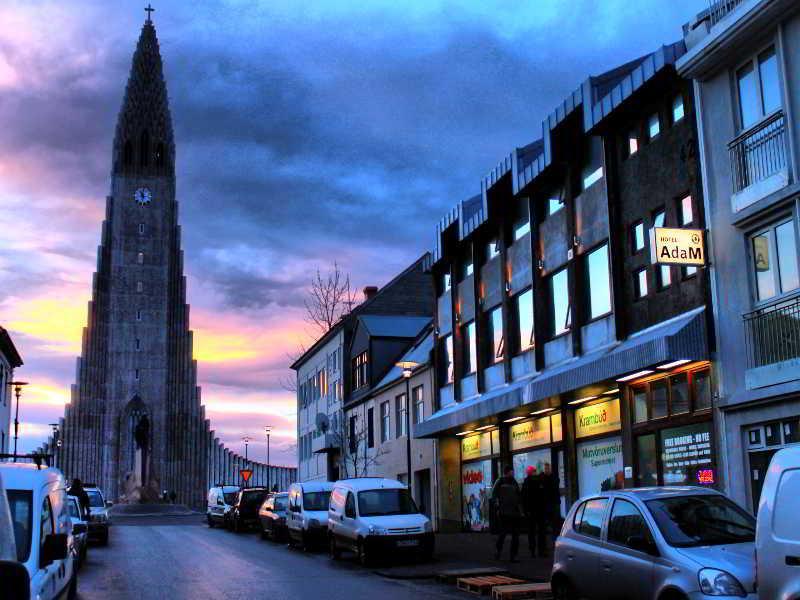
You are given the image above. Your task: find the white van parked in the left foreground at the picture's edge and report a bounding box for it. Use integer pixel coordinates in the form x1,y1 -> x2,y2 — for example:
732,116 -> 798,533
0,463 -> 78,600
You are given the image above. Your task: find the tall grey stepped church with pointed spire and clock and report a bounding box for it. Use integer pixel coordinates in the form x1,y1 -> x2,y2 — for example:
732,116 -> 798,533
54,18 -> 296,506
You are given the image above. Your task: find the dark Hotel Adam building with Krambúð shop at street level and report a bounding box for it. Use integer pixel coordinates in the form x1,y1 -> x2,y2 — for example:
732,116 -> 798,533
415,42 -> 721,531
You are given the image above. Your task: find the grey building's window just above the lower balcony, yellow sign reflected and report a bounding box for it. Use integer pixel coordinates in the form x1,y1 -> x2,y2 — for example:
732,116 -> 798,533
751,220 -> 800,300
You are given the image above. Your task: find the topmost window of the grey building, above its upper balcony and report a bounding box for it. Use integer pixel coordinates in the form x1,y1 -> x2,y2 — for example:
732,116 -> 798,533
736,48 -> 781,129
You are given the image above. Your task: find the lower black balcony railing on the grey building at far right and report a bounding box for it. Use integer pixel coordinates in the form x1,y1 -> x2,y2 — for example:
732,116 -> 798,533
744,297 -> 800,369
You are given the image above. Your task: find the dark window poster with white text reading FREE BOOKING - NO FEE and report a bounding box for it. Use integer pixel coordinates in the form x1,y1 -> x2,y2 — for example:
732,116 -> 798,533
661,423 -> 713,485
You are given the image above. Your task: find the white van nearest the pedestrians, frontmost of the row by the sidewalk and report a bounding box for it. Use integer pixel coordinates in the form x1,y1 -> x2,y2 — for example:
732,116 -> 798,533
328,477 -> 434,565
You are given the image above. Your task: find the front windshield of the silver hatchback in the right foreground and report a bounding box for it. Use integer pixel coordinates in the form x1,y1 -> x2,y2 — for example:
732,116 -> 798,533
646,495 -> 756,548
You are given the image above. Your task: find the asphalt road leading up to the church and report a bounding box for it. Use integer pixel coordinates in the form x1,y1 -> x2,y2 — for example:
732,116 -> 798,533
78,516 -> 464,600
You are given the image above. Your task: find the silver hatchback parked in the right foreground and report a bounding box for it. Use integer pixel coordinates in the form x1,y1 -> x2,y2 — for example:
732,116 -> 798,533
552,487 -> 756,600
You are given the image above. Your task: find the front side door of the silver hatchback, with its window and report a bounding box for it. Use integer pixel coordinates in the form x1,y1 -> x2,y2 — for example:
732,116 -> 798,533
600,499 -> 655,600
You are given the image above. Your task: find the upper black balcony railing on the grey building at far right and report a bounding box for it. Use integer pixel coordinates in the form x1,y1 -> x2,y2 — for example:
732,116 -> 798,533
728,111 -> 786,193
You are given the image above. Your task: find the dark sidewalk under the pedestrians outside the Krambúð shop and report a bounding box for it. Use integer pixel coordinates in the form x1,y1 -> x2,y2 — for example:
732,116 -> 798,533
375,533 -> 553,581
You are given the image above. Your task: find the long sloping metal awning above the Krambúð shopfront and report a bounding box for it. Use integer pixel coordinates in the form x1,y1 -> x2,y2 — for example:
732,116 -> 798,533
414,307 -> 708,438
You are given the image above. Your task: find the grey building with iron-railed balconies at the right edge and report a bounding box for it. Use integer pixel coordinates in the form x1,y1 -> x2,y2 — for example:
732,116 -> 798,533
678,0 -> 800,510
